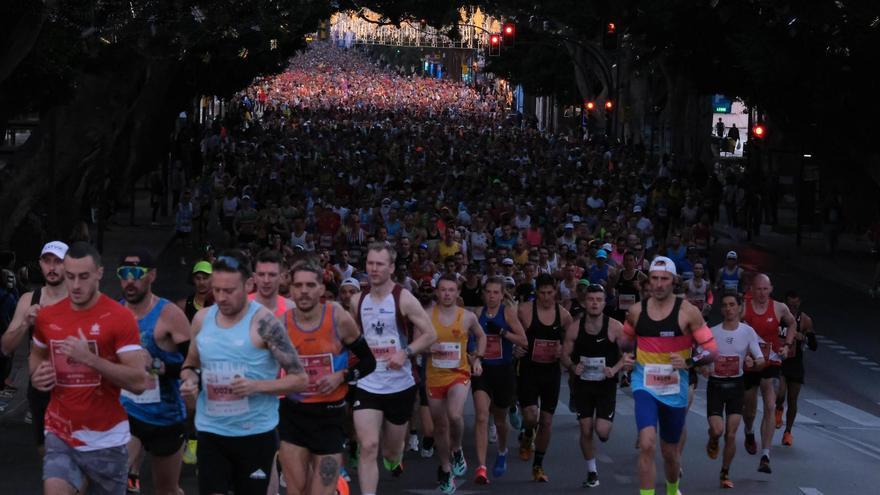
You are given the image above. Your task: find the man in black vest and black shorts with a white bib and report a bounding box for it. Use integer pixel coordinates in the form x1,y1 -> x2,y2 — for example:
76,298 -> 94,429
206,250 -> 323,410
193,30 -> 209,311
560,284 -> 632,488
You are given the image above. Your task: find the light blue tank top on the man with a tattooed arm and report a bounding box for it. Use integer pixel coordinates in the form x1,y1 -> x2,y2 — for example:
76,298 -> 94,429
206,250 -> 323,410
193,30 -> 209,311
196,301 -> 278,437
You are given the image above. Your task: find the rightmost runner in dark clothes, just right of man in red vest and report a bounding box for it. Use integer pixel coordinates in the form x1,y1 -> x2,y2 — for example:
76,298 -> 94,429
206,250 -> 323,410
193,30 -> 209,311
776,291 -> 819,447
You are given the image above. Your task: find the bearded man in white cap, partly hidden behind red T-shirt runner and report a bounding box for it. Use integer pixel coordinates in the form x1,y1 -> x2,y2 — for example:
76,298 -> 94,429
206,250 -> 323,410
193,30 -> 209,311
0,241 -> 67,456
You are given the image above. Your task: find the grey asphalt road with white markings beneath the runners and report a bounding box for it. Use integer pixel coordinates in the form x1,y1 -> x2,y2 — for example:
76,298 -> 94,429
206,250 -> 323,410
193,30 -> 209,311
0,233 -> 880,495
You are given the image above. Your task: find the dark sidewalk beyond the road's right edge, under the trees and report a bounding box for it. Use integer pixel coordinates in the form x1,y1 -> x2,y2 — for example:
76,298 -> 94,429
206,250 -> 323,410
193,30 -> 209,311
713,223 -> 875,296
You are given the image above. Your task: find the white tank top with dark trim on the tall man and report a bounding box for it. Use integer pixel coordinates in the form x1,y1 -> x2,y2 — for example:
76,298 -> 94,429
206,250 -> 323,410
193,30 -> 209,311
357,292 -> 416,394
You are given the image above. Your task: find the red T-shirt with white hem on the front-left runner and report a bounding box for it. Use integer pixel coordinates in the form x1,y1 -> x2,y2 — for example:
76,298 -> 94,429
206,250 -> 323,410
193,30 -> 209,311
34,294 -> 141,451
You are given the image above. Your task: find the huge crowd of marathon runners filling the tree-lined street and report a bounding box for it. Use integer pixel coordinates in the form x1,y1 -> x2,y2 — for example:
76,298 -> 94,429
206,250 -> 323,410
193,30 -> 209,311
2,45 -> 816,495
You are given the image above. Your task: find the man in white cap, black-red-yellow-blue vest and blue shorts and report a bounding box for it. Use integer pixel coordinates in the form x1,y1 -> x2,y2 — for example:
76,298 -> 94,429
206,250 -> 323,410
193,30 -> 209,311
621,256 -> 717,495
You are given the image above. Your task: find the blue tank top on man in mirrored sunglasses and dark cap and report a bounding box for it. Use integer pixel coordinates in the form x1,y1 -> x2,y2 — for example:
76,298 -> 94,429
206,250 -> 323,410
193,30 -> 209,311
119,297 -> 186,426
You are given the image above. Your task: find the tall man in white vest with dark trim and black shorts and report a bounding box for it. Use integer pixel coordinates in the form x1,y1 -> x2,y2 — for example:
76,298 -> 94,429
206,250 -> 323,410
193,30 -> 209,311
351,242 -> 437,495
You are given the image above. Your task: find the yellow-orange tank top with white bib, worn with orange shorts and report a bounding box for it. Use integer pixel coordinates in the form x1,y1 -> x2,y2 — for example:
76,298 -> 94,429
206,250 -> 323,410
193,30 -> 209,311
426,306 -> 471,387
